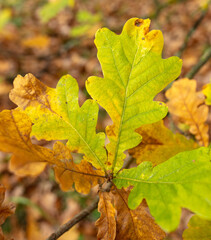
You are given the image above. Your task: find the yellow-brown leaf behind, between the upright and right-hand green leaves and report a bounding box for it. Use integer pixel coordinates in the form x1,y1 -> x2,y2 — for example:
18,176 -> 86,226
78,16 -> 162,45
129,121 -> 197,166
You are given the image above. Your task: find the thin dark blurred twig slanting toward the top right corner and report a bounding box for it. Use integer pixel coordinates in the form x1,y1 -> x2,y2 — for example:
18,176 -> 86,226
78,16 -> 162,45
176,1 -> 210,57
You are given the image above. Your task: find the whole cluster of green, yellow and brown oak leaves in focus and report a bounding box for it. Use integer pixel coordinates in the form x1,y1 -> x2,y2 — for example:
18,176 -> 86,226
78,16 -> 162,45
0,18 -> 211,239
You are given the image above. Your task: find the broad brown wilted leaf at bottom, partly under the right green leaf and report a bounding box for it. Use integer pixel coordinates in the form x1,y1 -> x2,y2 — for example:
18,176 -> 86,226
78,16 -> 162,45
111,189 -> 166,240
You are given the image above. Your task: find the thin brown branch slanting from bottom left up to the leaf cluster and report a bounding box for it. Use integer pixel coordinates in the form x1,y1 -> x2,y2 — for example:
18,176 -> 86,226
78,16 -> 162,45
46,197 -> 99,240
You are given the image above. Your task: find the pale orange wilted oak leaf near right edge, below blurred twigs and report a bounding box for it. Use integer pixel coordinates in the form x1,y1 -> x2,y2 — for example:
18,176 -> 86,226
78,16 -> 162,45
166,78 -> 209,146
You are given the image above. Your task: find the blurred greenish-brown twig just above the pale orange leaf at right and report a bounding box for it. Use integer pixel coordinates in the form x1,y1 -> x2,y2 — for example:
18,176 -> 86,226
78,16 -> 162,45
185,46 -> 211,78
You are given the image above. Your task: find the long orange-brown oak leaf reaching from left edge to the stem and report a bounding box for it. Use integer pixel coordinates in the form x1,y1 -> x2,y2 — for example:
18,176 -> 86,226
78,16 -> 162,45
0,109 -> 103,194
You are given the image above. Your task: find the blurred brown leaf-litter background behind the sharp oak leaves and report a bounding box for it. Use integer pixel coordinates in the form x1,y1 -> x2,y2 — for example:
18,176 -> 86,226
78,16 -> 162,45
0,0 -> 211,240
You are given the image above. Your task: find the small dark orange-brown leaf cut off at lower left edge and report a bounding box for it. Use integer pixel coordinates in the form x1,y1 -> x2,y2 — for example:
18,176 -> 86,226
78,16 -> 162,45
0,185 -> 15,240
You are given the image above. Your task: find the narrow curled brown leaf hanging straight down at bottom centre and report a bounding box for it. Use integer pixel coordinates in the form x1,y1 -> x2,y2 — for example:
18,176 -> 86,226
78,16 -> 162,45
96,192 -> 116,240
